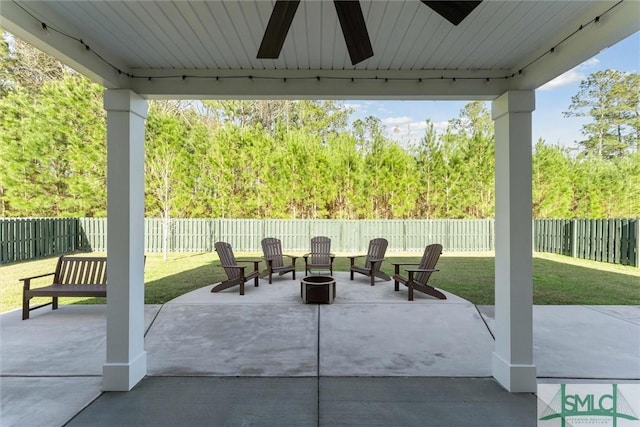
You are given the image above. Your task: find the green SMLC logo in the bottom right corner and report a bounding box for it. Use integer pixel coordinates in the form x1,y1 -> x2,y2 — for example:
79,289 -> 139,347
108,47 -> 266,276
540,384 -> 638,427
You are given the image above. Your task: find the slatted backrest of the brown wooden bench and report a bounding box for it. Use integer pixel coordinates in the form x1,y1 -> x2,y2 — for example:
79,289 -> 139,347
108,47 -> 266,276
53,255 -> 107,285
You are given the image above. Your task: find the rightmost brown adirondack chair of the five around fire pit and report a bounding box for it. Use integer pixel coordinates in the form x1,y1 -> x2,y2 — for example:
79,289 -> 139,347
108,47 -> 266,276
391,243 -> 447,301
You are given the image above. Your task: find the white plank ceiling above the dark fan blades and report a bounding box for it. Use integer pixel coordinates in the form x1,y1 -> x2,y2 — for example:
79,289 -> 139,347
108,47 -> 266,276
6,0 -> 594,70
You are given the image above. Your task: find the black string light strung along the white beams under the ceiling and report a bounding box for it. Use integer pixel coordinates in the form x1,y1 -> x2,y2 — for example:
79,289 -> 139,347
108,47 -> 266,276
13,0 -> 624,83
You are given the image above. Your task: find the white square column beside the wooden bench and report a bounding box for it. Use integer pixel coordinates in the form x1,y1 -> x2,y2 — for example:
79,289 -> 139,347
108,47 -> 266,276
102,89 -> 147,391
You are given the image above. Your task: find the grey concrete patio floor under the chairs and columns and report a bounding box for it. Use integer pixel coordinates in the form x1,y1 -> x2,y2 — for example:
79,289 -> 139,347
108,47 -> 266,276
0,272 -> 640,426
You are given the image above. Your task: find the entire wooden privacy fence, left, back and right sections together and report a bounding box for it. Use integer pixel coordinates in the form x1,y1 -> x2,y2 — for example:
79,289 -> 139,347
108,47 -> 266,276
0,218 -> 640,267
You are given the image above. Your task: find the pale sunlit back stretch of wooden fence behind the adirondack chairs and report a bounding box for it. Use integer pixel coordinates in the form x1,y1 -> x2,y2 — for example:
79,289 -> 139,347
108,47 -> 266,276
79,218 -> 494,252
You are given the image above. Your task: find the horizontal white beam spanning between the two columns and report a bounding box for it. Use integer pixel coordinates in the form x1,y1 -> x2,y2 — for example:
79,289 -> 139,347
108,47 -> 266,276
131,70 -> 508,100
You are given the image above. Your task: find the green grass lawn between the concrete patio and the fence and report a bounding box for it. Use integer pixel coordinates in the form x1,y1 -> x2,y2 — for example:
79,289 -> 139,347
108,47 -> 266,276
0,253 -> 640,312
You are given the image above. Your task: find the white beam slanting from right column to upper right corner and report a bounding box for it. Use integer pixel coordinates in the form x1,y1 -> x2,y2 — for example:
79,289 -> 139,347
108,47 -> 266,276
509,0 -> 640,90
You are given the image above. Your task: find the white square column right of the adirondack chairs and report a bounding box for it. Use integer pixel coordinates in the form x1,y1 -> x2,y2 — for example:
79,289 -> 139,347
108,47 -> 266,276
492,90 -> 537,392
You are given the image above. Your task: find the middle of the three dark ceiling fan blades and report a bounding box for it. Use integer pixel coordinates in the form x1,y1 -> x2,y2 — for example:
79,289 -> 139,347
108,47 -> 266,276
333,0 -> 373,65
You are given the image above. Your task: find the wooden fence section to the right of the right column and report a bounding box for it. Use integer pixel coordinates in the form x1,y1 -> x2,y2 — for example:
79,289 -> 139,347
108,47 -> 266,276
533,219 -> 640,267
